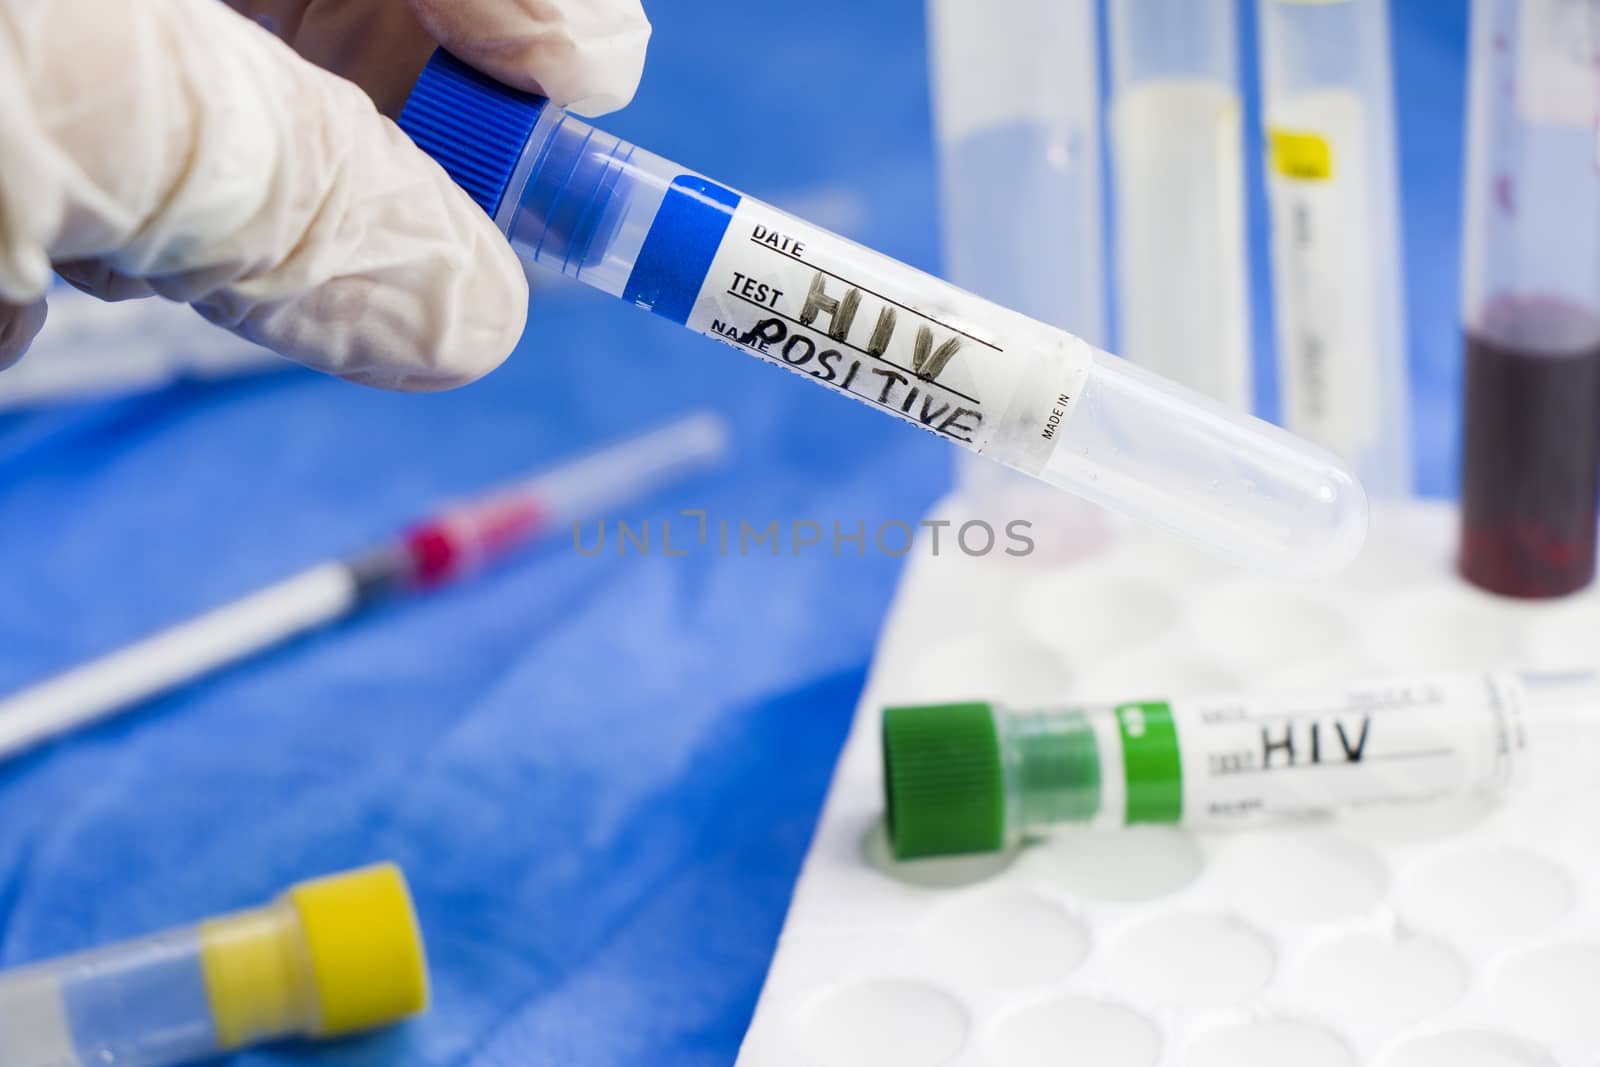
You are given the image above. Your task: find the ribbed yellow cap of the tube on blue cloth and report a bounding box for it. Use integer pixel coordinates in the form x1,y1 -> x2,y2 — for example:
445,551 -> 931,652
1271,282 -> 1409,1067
285,864 -> 427,1037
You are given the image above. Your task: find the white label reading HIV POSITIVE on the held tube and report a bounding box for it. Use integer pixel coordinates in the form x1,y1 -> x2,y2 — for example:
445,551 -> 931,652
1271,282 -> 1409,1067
686,197 -> 1091,472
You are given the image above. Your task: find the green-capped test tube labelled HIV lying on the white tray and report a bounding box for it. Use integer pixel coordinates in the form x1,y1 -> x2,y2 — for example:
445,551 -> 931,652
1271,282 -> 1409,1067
883,670 -> 1600,859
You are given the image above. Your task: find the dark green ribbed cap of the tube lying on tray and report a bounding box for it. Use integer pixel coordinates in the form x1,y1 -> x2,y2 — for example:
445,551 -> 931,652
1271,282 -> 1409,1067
883,704 -> 1005,859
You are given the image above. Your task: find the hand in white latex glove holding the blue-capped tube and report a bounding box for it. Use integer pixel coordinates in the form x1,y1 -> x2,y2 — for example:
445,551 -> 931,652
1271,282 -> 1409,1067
0,0 -> 650,390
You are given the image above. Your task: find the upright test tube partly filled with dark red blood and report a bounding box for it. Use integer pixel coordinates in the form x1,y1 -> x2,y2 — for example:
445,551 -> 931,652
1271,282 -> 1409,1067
1458,0 -> 1600,597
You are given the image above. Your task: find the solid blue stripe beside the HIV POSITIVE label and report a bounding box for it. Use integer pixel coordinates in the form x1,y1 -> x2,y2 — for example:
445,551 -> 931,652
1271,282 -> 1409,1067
622,174 -> 739,326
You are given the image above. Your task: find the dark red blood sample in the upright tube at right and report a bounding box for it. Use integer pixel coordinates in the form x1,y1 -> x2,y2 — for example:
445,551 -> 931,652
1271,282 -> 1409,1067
1458,299 -> 1600,597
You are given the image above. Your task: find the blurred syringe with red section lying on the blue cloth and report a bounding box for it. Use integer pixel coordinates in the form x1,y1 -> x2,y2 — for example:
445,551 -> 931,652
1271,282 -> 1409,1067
0,414 -> 728,760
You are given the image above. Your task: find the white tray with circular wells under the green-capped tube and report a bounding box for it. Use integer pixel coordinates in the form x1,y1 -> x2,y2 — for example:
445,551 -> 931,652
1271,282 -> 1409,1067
739,498 -> 1600,1067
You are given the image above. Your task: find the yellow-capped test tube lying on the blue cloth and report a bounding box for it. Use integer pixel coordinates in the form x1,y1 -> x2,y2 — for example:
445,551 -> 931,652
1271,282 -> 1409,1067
0,864 -> 427,1067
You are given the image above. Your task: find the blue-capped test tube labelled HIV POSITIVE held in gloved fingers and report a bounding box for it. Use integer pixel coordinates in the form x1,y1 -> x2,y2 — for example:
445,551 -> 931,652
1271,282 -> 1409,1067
400,53 -> 1366,574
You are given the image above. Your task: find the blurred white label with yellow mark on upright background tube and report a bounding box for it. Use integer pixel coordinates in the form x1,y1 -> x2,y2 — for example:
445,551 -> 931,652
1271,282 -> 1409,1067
1267,91 -> 1382,461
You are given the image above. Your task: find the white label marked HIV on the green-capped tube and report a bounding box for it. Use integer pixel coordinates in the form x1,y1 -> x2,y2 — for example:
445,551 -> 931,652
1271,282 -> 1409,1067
1164,675 -> 1525,827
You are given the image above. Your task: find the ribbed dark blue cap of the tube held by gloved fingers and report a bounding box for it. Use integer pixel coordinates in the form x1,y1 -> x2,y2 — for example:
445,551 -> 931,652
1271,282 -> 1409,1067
400,48 -> 549,218
